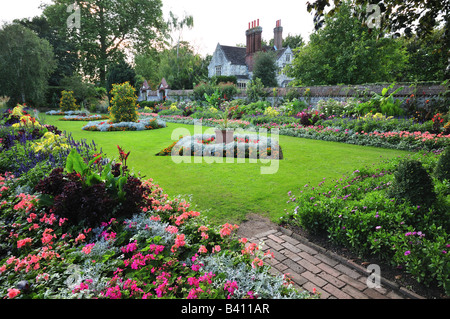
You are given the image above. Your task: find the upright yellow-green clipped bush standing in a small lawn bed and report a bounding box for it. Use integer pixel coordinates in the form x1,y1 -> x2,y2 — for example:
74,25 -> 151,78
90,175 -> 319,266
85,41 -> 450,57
109,82 -> 139,123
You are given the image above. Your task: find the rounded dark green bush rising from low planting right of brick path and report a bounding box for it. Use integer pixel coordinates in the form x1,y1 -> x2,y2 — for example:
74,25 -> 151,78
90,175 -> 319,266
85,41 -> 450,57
391,160 -> 436,207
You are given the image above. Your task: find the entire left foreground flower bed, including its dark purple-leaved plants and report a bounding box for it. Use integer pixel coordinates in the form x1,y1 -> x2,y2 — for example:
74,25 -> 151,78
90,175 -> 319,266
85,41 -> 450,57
0,107 -> 312,299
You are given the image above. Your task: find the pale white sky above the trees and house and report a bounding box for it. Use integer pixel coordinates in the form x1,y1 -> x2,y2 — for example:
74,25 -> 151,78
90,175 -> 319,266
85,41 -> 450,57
0,0 -> 314,56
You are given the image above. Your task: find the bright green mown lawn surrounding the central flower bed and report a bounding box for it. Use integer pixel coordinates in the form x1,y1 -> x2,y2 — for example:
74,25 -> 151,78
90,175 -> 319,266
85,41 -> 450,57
45,116 -> 408,223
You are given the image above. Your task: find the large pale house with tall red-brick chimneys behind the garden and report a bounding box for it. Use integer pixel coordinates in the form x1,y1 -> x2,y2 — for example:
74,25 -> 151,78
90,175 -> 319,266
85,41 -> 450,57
208,19 -> 293,89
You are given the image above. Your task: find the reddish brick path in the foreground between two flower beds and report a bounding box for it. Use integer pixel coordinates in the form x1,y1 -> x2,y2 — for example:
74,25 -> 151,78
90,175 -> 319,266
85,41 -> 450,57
244,227 -> 424,299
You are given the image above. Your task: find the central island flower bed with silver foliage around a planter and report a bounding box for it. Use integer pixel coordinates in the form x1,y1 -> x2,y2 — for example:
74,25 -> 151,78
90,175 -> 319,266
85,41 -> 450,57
157,134 -> 283,159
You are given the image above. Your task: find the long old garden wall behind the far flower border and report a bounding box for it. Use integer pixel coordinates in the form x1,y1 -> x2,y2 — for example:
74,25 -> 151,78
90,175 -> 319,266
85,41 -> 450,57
149,83 -> 445,106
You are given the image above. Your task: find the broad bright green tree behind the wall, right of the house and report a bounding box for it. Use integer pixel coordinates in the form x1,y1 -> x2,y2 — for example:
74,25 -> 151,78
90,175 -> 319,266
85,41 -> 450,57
287,4 -> 407,85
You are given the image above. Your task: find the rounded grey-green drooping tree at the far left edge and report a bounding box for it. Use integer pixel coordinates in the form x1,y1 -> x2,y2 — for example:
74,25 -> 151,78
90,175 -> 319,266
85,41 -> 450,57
0,24 -> 56,105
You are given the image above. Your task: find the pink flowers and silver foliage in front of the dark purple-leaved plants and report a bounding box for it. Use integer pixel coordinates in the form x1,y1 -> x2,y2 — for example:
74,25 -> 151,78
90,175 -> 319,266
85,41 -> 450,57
0,168 -> 311,299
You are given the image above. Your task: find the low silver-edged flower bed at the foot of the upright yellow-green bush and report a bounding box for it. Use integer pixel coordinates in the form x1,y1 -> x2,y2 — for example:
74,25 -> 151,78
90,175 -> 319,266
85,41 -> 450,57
83,118 -> 167,132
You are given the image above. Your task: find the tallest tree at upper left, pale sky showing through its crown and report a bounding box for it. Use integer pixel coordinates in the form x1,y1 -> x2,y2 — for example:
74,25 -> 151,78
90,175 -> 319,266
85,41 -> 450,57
44,0 -> 166,86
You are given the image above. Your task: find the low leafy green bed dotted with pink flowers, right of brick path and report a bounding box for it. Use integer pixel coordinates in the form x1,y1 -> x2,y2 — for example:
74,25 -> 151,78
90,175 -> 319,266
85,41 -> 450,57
281,153 -> 450,295
